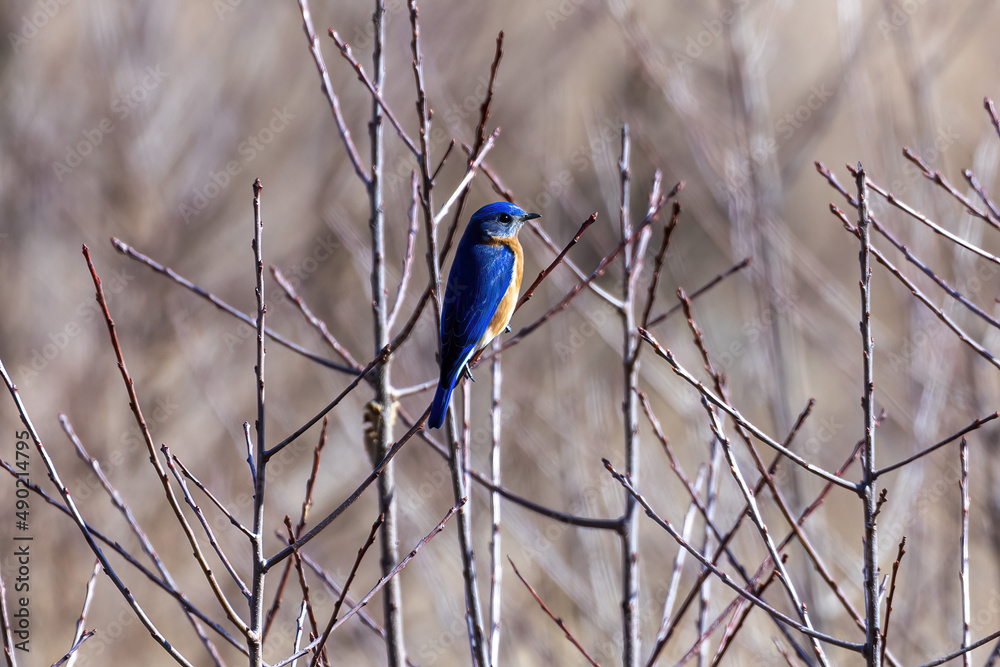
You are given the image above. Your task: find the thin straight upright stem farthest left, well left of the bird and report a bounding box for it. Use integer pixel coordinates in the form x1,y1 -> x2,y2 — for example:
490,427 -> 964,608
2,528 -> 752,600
247,178 -> 267,667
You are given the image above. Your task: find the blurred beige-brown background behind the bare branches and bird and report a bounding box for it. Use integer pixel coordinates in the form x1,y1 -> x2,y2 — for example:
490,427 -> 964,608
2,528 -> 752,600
0,0 -> 1000,667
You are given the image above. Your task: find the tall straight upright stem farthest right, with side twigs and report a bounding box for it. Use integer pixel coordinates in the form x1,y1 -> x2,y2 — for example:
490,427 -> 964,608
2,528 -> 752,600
856,163 -> 882,667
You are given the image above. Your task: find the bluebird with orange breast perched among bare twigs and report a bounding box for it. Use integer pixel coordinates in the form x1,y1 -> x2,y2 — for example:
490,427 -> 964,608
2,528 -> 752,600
427,202 -> 542,428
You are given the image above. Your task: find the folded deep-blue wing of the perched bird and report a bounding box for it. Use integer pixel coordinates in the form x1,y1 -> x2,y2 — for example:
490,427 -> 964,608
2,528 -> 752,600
441,244 -> 515,384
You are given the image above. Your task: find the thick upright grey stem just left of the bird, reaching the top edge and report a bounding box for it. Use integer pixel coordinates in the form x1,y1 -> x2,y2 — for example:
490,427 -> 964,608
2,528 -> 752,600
368,0 -> 406,667
